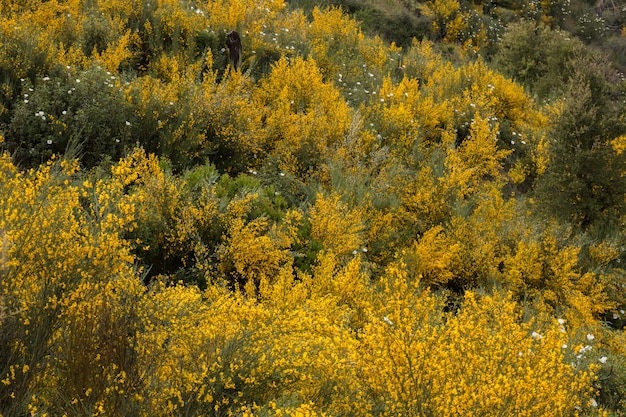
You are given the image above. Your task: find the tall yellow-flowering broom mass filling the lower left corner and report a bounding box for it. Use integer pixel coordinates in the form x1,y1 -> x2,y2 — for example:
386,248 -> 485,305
0,154 -> 140,412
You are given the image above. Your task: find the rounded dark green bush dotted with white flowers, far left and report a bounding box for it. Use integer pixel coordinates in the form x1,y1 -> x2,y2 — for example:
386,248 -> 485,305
5,67 -> 131,167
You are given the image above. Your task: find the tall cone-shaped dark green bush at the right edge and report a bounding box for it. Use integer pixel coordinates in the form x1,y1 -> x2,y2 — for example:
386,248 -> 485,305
535,68 -> 626,228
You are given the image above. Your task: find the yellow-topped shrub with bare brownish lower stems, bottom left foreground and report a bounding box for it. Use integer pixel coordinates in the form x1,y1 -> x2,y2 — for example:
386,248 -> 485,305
33,270 -> 144,415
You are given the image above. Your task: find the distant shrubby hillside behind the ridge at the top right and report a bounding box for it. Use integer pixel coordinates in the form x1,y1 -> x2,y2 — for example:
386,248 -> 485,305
304,0 -> 626,72
